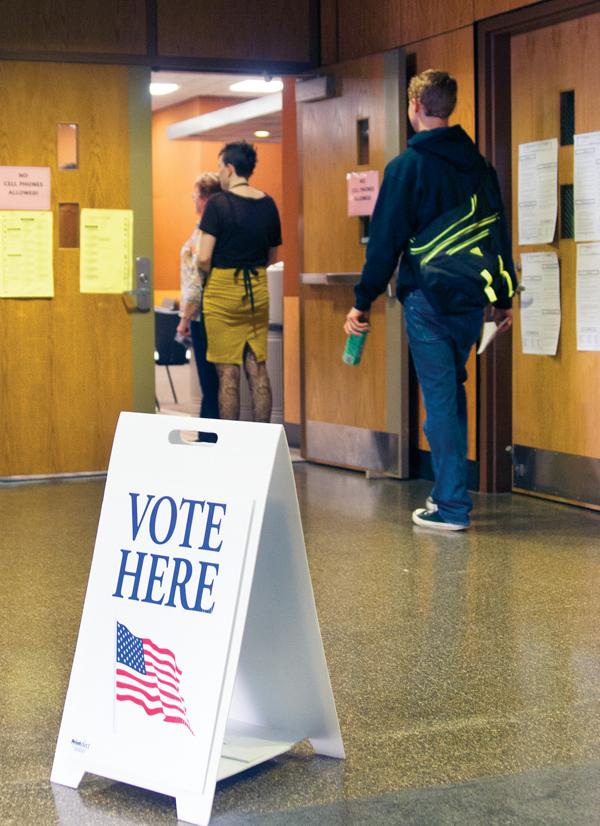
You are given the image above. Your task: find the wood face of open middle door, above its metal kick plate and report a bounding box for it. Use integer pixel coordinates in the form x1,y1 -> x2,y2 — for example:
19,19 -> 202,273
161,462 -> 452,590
301,55 -> 387,431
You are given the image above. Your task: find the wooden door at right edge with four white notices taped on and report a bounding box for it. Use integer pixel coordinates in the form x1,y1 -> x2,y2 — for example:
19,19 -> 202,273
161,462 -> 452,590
511,14 -> 600,506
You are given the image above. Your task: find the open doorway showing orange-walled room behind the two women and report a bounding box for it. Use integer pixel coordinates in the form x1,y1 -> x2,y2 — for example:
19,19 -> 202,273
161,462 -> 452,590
152,71 -> 283,423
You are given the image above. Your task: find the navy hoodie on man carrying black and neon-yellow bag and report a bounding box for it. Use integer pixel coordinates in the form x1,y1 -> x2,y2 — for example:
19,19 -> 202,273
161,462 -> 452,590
354,126 -> 517,310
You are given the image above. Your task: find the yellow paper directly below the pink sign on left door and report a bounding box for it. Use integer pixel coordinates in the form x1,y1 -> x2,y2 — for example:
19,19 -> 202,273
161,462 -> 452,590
0,210 -> 54,298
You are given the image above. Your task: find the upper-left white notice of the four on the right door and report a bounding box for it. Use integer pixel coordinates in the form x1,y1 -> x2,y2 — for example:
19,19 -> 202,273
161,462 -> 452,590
519,138 -> 558,245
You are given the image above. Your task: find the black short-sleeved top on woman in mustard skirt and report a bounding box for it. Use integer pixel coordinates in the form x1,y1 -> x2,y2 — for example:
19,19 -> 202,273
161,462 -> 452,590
200,192 -> 281,268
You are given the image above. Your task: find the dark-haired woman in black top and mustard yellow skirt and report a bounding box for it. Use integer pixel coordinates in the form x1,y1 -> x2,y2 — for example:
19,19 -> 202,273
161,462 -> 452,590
198,141 -> 281,422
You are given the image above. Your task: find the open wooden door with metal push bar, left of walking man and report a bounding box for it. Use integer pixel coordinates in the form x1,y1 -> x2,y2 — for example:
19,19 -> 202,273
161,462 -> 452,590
299,53 -> 407,475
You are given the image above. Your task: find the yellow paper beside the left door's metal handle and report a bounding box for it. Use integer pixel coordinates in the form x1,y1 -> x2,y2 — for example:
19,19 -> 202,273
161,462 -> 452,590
79,209 -> 133,293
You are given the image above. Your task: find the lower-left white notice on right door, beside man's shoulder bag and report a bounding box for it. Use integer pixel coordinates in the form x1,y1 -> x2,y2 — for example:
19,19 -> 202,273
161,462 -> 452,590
521,252 -> 560,356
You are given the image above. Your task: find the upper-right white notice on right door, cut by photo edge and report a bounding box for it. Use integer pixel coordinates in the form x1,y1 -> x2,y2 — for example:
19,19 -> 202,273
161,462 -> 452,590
573,132 -> 600,241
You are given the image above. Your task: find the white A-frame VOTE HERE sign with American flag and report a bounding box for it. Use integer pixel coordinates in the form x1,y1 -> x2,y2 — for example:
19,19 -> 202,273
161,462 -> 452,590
51,413 -> 344,826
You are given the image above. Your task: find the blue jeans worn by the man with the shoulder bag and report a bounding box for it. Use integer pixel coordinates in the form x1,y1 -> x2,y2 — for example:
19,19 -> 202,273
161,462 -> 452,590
404,290 -> 483,525
